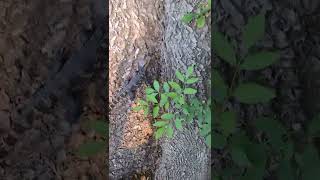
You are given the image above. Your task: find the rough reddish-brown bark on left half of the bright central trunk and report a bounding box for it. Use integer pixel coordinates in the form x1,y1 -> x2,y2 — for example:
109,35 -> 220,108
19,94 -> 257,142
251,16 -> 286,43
109,0 -> 163,179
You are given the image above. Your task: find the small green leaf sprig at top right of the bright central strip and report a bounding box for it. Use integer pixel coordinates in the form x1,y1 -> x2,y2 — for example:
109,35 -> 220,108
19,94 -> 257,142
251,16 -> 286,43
181,0 -> 211,28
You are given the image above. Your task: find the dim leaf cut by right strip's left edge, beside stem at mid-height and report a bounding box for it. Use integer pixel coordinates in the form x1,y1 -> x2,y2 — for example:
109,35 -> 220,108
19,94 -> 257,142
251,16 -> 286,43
212,70 -> 228,103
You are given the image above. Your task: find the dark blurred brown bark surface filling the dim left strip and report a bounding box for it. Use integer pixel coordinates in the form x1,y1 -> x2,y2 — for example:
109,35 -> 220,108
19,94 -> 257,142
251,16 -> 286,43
0,0 -> 107,180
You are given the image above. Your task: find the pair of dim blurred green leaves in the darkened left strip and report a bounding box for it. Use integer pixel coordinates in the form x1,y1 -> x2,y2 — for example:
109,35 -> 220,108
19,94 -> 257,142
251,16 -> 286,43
76,120 -> 108,158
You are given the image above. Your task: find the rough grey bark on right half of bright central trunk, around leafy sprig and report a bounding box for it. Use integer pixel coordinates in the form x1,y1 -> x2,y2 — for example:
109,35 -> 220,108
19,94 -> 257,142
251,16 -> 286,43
155,0 -> 211,180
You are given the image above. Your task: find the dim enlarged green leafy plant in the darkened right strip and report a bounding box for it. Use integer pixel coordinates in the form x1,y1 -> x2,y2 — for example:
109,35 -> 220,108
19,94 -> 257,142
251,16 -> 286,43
212,13 -> 320,180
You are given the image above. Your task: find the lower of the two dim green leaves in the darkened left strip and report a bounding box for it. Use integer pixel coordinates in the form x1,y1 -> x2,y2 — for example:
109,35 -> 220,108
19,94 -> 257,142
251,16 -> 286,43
76,140 -> 106,157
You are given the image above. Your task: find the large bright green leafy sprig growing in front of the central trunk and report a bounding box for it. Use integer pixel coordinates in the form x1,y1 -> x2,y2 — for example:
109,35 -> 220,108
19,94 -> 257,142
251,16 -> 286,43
133,65 -> 211,145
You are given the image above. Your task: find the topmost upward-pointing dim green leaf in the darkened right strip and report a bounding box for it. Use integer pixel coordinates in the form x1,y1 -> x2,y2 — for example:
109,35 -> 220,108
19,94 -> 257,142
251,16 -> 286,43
242,13 -> 265,49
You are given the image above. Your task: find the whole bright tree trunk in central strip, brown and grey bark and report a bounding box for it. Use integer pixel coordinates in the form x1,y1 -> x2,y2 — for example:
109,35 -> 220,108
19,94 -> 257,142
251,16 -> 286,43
109,0 -> 210,180
